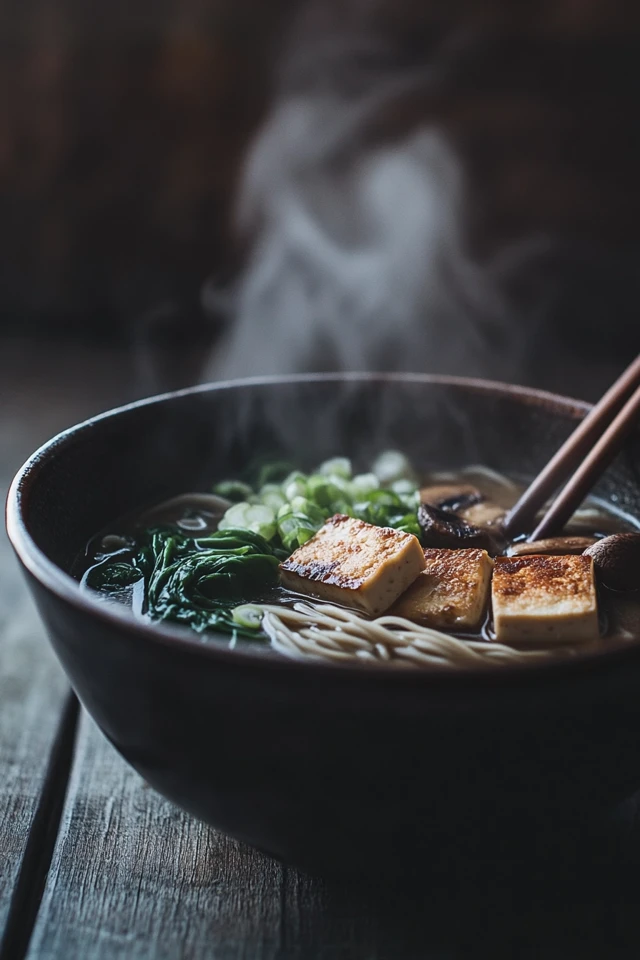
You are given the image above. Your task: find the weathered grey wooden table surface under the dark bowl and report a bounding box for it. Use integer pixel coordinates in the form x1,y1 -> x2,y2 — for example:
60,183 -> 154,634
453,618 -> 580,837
0,341 -> 640,960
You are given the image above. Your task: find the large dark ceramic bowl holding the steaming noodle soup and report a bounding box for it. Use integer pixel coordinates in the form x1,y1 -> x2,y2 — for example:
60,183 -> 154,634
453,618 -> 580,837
8,376 -> 640,870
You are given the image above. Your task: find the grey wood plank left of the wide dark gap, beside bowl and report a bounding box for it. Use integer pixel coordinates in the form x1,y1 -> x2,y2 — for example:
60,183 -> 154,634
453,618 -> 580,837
0,340 -> 141,937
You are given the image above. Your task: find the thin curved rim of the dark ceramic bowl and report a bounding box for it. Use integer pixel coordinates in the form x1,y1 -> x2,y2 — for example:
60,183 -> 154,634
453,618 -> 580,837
6,372 -> 640,687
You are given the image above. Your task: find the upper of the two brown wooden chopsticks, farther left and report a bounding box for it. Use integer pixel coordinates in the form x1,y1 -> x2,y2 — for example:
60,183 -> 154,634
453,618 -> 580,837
504,355 -> 640,537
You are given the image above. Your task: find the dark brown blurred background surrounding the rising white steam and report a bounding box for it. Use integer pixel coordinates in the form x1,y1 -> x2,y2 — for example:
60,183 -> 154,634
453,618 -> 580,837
0,0 -> 640,397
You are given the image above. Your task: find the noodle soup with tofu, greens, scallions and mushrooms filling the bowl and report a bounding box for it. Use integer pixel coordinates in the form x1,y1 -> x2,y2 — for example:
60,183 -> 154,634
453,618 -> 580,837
81,451 -> 640,668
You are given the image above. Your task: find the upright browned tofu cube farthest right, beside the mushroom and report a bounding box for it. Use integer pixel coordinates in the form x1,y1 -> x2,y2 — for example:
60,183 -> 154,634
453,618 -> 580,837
492,554 -> 599,647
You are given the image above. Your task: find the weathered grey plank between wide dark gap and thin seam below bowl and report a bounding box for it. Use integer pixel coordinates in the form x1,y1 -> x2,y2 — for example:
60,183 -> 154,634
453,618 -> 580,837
28,714 -> 284,960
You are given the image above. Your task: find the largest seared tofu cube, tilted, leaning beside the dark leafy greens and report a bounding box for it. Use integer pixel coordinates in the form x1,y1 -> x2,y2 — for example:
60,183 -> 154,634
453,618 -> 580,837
280,514 -> 425,617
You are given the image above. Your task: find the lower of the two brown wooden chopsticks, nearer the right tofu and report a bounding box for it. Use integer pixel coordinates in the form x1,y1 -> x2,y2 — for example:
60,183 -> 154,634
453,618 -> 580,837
528,387 -> 640,541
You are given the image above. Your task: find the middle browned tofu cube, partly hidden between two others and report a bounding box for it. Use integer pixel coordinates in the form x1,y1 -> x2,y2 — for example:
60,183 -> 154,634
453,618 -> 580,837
390,549 -> 493,632
